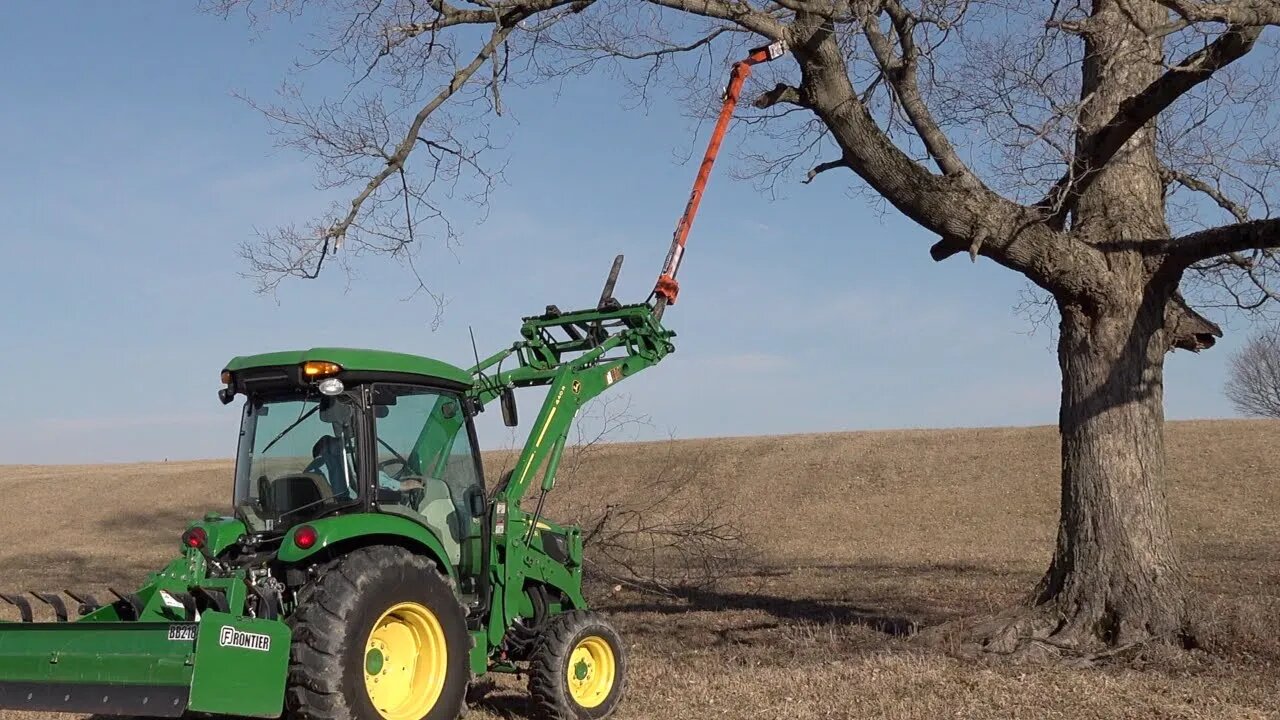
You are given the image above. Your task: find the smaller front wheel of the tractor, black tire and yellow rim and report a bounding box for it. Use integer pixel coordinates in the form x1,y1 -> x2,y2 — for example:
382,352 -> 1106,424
529,610 -> 627,720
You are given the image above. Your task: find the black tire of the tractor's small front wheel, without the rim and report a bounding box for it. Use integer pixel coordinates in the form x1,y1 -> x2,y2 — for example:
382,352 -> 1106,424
529,610 -> 627,720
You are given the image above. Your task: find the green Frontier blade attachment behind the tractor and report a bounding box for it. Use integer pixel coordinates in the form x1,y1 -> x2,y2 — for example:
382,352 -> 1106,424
0,607 -> 292,717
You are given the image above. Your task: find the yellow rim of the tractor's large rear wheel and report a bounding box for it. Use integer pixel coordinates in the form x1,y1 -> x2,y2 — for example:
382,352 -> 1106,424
365,602 -> 449,720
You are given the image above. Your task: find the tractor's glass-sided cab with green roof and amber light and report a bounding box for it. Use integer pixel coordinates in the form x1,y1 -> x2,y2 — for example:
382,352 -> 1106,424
221,348 -> 485,568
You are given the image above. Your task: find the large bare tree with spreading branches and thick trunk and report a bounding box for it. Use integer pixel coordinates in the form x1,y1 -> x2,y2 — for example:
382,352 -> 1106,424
218,0 -> 1280,651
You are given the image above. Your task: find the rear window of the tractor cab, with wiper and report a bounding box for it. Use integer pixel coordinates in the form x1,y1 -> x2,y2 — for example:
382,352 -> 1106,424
236,392 -> 360,532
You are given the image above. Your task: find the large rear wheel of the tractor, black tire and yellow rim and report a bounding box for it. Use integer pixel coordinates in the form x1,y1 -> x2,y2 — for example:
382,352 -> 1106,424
285,546 -> 471,720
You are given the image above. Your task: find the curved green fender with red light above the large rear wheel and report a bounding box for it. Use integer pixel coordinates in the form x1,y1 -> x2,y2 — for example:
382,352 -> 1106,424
276,512 -> 457,580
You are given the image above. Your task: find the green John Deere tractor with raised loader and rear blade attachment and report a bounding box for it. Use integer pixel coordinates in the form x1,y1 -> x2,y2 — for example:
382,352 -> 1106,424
0,258 -> 675,720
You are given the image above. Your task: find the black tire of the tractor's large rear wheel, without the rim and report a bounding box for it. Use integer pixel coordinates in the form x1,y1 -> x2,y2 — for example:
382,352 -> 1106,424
285,546 -> 471,720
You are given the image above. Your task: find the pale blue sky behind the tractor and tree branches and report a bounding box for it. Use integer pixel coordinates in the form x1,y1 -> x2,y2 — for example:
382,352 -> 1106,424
0,1 -> 1247,462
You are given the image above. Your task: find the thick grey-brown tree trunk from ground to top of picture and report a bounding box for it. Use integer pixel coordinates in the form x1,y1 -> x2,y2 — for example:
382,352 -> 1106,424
1003,0 -> 1192,651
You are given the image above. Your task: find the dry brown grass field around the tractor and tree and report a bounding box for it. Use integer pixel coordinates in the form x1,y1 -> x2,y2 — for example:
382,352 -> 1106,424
0,421 -> 1280,720
